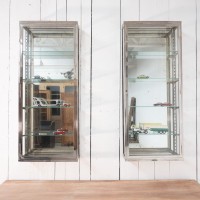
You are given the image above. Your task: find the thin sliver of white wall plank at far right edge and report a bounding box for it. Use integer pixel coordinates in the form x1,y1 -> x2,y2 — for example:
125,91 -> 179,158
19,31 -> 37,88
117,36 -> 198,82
196,1 -> 200,183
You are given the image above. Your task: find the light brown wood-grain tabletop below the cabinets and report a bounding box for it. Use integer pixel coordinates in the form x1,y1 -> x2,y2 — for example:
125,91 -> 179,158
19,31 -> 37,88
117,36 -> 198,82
0,180 -> 200,200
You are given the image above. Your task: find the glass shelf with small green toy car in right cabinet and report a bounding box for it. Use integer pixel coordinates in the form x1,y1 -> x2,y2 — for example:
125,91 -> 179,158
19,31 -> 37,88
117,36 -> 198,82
128,77 -> 179,83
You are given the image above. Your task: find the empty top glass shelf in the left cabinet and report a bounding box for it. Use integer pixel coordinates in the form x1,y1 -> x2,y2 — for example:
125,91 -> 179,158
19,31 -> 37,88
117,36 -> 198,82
23,51 -> 74,59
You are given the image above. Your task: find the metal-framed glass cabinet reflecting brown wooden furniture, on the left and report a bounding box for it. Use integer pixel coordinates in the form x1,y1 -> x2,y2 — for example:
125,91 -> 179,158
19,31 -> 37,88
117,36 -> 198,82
19,21 -> 79,161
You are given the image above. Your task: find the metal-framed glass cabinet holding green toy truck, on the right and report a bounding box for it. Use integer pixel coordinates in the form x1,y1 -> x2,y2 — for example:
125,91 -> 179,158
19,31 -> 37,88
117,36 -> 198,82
122,21 -> 182,160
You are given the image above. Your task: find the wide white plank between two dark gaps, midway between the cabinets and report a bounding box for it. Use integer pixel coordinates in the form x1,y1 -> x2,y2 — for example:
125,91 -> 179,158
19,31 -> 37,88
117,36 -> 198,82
91,0 -> 120,180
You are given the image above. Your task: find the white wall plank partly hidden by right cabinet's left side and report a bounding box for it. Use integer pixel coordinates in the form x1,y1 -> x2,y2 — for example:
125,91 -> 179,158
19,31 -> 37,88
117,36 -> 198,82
120,0 -> 140,180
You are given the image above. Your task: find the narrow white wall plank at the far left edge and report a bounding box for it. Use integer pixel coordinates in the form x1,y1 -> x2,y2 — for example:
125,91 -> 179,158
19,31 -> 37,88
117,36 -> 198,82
0,0 -> 9,184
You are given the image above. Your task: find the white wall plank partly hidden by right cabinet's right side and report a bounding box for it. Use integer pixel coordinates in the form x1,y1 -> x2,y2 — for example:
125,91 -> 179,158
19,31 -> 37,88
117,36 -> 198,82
169,0 -> 196,179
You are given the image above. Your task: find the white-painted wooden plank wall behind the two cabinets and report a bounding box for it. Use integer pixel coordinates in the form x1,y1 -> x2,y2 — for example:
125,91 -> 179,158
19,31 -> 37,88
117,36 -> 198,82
0,0 -> 200,182
